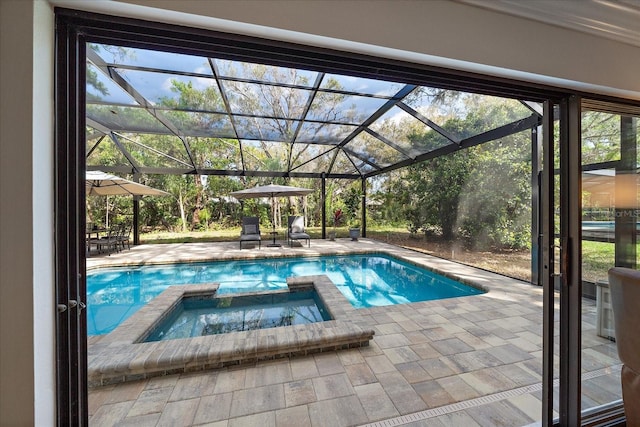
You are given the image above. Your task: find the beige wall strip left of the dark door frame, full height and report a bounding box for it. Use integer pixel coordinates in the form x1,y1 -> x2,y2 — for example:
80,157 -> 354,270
0,0 -> 55,426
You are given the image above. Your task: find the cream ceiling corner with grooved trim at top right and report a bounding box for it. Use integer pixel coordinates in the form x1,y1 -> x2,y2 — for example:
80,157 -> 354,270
457,0 -> 640,46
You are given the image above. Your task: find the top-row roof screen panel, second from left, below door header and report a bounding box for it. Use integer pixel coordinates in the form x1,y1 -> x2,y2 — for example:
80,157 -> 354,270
213,59 -> 318,87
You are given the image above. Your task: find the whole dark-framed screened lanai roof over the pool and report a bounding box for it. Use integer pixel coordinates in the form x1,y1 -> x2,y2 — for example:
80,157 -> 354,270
86,44 -> 541,178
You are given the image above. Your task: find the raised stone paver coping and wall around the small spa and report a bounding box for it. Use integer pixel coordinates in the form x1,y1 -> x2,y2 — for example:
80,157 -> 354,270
88,275 -> 375,387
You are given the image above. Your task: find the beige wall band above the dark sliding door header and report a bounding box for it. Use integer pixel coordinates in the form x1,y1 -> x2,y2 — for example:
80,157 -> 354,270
66,0 -> 640,100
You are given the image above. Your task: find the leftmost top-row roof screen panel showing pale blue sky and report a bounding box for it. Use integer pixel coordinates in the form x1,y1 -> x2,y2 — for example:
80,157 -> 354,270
89,43 -> 213,75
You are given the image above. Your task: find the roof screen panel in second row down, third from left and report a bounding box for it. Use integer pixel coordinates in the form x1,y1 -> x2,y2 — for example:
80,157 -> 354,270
306,92 -> 387,124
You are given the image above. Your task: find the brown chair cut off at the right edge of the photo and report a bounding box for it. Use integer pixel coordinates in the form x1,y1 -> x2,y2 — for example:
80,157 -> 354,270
609,267 -> 640,426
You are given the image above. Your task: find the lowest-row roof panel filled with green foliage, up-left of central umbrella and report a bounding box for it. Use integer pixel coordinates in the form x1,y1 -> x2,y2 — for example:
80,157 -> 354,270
188,138 -> 242,170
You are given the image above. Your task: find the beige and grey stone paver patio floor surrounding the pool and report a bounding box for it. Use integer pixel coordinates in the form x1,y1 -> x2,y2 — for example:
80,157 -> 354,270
87,239 -> 621,427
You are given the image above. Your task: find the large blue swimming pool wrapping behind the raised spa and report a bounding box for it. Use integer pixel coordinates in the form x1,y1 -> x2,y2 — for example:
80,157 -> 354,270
87,254 -> 483,335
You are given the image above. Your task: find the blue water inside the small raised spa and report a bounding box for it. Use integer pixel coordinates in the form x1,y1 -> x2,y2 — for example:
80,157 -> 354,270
144,291 -> 331,342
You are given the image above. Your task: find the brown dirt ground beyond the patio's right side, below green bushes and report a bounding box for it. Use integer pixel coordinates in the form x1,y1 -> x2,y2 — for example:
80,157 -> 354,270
367,232 -> 531,282
